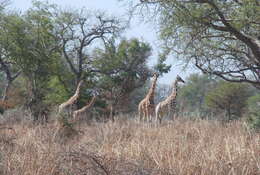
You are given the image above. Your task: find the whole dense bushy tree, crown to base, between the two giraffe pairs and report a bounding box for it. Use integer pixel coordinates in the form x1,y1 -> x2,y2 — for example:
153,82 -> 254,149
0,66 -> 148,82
94,39 -> 162,117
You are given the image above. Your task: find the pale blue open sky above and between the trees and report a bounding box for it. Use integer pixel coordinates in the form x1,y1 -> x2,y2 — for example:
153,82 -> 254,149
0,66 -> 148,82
9,0 -> 197,84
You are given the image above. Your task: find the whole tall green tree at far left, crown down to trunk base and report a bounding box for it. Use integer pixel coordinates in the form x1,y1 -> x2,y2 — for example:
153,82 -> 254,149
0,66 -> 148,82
5,1 -> 59,121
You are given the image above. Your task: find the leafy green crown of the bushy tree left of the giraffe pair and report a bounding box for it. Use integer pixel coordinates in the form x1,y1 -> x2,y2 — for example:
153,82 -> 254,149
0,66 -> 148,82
95,39 -> 151,77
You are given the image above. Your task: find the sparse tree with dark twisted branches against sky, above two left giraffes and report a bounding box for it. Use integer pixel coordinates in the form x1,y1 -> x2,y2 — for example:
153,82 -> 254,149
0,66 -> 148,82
55,9 -> 124,86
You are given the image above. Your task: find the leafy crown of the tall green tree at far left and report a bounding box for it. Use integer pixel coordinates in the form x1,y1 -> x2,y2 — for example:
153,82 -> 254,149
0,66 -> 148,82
1,2 -> 58,86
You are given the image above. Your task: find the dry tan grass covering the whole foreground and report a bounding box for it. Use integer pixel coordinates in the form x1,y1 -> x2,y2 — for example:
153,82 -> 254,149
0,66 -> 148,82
0,116 -> 260,175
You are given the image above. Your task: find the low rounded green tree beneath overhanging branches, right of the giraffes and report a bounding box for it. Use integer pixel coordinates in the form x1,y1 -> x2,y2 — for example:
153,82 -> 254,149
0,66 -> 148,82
205,81 -> 250,121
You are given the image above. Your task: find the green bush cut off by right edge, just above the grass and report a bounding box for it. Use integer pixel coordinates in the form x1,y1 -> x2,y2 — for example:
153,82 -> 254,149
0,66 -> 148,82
247,94 -> 260,130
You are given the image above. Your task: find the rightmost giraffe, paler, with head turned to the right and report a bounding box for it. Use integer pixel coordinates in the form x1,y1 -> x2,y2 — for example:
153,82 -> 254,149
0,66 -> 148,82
155,75 -> 185,123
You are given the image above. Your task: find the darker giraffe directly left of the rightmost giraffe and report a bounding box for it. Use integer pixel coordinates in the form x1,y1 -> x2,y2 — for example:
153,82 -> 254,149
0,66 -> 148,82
138,73 -> 158,121
